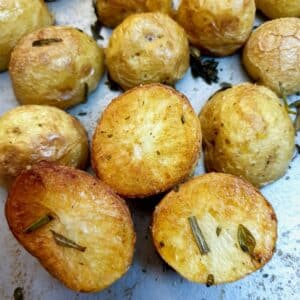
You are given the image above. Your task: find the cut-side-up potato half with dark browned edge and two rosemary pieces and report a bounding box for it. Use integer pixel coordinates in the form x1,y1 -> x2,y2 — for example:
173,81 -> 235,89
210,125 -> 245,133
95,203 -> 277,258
5,162 -> 135,292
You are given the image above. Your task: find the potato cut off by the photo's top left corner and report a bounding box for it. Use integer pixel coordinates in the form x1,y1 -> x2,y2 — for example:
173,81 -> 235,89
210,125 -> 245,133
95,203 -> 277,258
0,0 -> 53,72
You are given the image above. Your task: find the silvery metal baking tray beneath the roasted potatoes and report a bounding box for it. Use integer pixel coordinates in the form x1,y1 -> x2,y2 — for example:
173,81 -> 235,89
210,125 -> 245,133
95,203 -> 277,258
0,0 -> 300,300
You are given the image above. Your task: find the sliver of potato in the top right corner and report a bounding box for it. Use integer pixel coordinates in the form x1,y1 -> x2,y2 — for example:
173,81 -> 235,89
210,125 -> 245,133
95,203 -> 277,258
255,0 -> 300,19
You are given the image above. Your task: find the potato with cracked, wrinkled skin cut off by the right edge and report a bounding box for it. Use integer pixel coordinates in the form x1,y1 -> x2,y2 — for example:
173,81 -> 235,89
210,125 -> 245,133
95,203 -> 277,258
243,18 -> 300,95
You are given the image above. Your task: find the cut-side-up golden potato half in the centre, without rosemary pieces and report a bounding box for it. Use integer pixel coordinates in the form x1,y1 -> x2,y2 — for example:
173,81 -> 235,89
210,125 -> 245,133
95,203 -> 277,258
92,84 -> 201,198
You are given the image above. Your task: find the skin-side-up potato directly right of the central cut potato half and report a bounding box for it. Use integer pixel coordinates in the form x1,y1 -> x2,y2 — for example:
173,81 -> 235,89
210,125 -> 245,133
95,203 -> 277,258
200,83 -> 295,187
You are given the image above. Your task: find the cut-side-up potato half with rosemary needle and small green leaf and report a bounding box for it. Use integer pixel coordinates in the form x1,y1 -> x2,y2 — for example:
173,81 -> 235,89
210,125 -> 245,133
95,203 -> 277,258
152,173 -> 277,285
